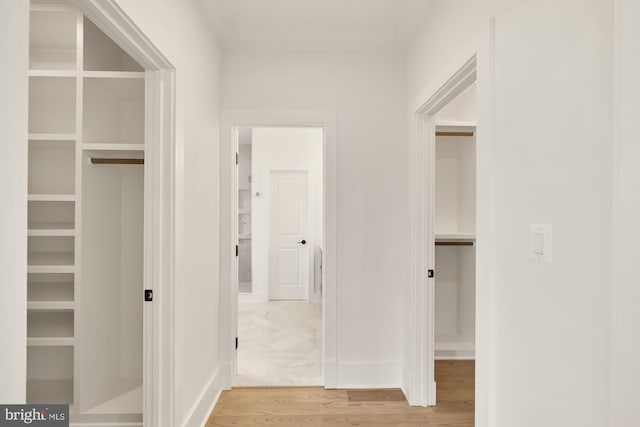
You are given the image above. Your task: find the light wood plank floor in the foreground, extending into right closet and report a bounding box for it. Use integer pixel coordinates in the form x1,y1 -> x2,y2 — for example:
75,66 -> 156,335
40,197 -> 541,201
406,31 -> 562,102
206,361 -> 475,427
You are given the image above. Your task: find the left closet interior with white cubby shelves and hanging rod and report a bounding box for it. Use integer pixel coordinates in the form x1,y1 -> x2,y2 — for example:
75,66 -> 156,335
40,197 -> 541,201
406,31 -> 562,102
27,2 -> 145,426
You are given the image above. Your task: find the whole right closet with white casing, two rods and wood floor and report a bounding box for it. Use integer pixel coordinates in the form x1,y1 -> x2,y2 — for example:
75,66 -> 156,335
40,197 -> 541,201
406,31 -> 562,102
404,55 -> 478,406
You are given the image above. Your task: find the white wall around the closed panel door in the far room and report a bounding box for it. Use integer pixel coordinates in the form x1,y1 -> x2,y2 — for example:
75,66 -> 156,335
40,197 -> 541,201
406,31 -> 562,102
251,127 -> 322,301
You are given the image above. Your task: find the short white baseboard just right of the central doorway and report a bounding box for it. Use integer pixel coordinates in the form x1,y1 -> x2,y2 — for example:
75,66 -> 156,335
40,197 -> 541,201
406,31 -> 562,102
337,362 -> 402,388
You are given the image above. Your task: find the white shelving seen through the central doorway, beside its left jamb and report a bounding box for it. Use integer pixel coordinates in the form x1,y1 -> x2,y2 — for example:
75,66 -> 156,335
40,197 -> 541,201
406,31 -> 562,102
238,135 -> 253,294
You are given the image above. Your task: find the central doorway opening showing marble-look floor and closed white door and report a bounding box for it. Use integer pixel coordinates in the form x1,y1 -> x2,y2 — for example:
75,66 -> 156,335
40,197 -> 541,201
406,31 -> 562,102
232,126 -> 324,386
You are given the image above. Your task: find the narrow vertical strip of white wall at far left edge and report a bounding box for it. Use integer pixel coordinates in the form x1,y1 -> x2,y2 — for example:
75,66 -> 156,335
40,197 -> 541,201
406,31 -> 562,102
0,0 -> 29,404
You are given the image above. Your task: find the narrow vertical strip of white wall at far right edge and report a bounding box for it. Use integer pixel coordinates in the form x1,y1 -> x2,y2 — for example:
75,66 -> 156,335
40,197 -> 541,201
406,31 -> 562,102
608,0 -> 640,427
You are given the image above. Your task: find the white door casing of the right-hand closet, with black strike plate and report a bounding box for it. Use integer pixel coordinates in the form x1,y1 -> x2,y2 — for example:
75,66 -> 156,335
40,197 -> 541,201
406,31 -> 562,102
403,54 -> 485,406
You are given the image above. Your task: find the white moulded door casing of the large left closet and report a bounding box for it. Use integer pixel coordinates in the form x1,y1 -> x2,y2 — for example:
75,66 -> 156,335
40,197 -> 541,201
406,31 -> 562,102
74,0 -> 175,427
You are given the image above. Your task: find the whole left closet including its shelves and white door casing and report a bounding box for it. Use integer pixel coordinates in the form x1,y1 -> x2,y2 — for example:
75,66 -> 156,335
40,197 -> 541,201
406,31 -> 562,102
25,0 -> 174,427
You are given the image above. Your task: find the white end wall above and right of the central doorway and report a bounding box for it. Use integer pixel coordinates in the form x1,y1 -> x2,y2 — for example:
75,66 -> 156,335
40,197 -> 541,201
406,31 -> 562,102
222,51 -> 409,386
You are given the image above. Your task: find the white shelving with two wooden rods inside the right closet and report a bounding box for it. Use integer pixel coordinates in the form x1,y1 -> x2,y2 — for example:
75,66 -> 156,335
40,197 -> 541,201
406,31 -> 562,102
435,122 -> 476,359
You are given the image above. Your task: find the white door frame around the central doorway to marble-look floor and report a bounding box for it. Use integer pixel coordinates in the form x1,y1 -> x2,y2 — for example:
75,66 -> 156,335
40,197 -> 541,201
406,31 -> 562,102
220,110 -> 338,389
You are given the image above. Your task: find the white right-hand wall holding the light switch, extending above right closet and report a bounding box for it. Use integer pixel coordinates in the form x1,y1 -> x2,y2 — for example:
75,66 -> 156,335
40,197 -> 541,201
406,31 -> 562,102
407,0 -> 613,427
